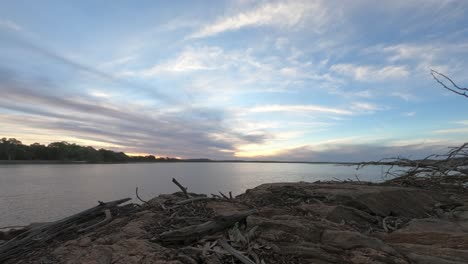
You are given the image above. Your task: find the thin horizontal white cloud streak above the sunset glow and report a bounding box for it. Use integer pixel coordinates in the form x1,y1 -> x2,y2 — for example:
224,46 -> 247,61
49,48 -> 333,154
248,105 -> 353,115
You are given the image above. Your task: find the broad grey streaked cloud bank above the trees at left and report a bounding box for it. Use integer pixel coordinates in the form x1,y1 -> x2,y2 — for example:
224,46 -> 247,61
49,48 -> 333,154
0,69 -> 268,158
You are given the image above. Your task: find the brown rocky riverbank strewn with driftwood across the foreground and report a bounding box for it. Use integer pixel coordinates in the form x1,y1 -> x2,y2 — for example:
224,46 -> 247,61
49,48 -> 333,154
0,177 -> 468,264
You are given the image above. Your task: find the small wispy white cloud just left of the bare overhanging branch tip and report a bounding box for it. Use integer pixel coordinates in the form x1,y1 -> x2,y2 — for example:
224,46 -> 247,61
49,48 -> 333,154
330,64 -> 409,82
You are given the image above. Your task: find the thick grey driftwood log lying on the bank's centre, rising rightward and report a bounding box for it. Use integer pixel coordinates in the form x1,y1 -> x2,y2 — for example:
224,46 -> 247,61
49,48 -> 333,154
160,209 -> 257,244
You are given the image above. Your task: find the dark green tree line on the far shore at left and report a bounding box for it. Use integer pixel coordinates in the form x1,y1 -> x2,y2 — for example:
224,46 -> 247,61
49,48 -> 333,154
0,138 -> 178,163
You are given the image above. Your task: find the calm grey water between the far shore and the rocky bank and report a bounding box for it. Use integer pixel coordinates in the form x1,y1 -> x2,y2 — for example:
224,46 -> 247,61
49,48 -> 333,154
0,163 -> 388,227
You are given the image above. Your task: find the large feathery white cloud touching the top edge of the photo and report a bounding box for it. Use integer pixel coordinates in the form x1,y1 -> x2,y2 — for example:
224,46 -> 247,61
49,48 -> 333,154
188,1 -> 326,39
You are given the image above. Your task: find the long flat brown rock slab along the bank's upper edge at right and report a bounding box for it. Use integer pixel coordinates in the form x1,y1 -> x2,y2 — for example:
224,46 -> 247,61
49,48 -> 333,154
239,182 -> 450,218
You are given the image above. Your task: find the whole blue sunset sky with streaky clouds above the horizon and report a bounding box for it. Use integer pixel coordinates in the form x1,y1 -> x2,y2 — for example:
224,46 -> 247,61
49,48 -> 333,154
0,0 -> 468,161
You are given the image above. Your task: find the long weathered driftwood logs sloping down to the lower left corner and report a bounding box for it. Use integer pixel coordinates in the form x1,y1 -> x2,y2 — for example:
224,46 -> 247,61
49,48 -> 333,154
0,198 -> 131,263
